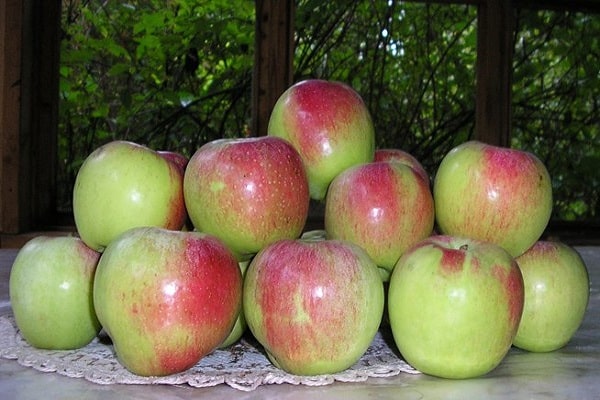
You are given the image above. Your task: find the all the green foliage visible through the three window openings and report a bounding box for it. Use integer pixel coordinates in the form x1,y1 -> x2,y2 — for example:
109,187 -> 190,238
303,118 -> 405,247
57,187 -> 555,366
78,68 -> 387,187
59,0 -> 600,220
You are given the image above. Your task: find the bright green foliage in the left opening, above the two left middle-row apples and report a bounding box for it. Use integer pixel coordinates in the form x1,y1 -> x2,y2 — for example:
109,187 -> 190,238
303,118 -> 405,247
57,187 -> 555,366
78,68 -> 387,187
58,0 -> 254,209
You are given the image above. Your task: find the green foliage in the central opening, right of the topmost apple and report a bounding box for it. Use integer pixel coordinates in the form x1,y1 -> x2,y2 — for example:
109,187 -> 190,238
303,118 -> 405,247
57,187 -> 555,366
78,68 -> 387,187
295,0 -> 477,173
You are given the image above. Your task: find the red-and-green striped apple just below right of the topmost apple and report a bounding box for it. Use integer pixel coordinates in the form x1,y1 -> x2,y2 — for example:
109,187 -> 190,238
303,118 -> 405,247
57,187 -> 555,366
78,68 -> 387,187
324,162 -> 435,280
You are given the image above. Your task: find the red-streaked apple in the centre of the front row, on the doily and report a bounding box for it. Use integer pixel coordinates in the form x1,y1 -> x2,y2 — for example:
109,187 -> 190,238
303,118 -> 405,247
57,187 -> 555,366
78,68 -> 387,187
243,237 -> 385,375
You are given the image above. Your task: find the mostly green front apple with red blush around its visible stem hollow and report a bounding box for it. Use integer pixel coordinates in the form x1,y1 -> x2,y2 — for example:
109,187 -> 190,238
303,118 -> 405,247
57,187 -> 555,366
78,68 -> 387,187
387,235 -> 524,379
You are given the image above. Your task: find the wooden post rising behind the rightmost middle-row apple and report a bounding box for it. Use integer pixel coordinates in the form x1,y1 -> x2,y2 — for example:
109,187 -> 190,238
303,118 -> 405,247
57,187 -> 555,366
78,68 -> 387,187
475,0 -> 514,146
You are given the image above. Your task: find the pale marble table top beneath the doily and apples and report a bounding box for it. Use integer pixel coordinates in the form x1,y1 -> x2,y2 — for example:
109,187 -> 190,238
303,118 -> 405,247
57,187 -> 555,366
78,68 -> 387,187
0,246 -> 600,400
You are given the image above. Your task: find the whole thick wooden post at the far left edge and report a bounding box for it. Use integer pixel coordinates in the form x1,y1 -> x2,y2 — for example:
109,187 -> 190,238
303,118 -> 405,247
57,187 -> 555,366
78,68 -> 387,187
0,0 -> 61,233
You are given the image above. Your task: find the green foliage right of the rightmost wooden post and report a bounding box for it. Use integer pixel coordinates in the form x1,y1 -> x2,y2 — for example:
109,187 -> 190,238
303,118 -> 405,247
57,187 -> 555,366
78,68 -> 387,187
512,11 -> 600,220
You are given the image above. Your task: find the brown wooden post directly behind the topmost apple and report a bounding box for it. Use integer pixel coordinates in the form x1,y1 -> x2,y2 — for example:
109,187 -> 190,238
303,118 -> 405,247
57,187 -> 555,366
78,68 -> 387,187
251,0 -> 295,136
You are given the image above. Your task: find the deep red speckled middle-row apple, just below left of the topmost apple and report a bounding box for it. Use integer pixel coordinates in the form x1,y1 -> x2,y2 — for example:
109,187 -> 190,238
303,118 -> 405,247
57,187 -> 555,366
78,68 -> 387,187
183,136 -> 310,260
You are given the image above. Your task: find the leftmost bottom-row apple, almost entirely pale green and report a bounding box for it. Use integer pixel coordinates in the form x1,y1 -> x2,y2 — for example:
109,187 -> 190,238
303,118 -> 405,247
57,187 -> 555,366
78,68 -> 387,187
9,236 -> 101,350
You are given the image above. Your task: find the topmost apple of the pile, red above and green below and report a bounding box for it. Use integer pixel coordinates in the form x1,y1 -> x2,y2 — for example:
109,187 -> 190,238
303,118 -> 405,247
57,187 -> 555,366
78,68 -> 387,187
267,79 -> 375,200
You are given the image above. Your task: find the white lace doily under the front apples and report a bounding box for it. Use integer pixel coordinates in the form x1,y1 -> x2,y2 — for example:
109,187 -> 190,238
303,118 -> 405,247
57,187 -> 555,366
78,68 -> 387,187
0,315 -> 418,391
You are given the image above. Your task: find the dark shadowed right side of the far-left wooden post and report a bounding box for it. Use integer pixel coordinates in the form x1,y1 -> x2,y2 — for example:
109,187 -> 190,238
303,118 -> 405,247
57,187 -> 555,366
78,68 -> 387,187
20,0 -> 62,230
